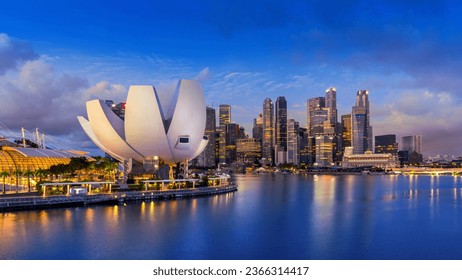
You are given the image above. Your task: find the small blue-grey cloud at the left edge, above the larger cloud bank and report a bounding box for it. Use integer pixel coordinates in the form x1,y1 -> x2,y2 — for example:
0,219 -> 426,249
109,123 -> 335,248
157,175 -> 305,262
0,33 -> 37,75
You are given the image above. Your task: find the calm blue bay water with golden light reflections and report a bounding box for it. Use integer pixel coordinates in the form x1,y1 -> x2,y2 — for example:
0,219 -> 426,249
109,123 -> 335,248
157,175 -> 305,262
0,174 -> 462,259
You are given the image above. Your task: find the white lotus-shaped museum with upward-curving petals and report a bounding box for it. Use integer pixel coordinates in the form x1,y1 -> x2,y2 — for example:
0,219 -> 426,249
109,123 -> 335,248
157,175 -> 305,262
77,80 -> 208,164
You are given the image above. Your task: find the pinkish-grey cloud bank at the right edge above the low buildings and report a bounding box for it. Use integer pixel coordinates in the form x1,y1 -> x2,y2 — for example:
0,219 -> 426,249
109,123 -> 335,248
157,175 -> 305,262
372,91 -> 462,155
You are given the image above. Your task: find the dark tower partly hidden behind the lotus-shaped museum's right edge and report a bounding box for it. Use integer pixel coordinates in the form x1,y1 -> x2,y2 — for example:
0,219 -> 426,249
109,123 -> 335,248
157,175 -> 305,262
197,107 -> 216,167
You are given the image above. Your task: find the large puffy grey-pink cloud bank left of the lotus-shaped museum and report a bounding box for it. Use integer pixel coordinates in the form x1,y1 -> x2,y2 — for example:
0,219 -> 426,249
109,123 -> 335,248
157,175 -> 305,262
0,35 -> 127,153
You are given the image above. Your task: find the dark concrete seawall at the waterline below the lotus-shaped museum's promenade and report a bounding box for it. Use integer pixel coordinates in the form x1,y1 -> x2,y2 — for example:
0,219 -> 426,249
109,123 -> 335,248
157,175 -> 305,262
0,184 -> 237,212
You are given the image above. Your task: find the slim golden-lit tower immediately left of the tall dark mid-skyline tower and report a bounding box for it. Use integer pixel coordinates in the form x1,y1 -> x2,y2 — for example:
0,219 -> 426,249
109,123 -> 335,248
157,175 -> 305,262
262,98 -> 274,164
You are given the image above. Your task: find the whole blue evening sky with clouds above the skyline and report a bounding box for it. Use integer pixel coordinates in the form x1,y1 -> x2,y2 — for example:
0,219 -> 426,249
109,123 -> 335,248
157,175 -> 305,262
0,0 -> 462,156
